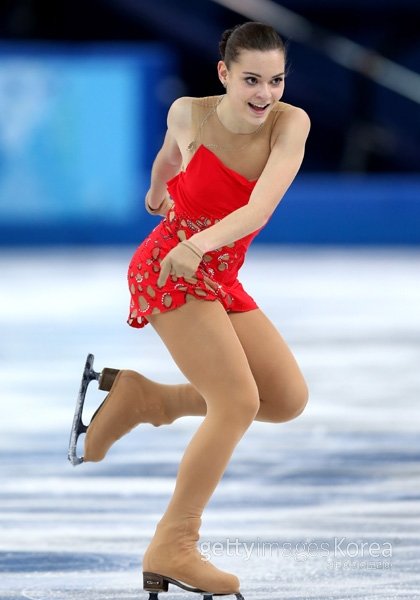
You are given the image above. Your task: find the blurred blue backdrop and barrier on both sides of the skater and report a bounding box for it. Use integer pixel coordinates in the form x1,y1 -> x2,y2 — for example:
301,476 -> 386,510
0,43 -> 420,247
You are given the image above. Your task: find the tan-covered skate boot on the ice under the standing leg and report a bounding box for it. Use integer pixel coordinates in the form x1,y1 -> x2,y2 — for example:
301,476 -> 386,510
143,517 -> 242,600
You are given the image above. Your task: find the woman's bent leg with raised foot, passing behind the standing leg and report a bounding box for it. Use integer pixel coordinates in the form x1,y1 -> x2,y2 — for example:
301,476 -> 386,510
84,309 -> 308,462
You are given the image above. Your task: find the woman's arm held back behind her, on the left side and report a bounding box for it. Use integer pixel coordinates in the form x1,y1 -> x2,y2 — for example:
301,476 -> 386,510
146,98 -> 191,209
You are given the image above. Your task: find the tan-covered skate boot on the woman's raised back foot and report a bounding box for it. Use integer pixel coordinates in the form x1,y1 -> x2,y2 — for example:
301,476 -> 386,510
83,369 -> 172,462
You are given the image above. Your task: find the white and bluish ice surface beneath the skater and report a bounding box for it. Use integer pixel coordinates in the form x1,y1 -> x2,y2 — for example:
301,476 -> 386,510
0,247 -> 420,600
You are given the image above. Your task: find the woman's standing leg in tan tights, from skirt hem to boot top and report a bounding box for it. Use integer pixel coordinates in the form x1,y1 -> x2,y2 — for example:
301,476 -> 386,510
150,300 -> 259,516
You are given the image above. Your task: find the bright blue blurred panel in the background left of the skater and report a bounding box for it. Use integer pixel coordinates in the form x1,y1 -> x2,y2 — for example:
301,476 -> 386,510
0,44 -> 176,245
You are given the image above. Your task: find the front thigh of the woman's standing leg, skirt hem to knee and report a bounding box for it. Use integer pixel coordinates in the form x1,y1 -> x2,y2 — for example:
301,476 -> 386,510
148,299 -> 259,419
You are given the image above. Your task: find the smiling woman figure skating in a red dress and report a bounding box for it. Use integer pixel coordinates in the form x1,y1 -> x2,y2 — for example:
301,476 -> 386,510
70,22 -> 310,598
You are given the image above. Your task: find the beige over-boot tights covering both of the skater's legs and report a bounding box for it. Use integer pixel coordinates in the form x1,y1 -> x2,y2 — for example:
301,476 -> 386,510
86,300 -> 307,594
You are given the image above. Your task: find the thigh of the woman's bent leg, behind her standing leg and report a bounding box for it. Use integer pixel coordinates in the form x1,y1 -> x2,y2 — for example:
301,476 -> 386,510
229,309 -> 308,422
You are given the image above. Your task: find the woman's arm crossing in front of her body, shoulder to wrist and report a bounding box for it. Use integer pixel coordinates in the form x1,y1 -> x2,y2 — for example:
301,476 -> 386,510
190,108 -> 310,253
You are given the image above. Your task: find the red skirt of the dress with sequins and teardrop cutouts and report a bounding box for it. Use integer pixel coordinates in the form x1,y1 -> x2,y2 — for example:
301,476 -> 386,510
127,209 -> 258,328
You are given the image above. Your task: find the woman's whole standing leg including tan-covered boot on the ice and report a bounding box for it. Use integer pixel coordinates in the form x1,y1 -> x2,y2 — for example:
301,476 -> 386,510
143,300 -> 259,593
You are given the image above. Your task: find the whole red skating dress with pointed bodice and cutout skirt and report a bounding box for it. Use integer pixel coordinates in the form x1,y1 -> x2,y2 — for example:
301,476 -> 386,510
128,95 -> 280,328
